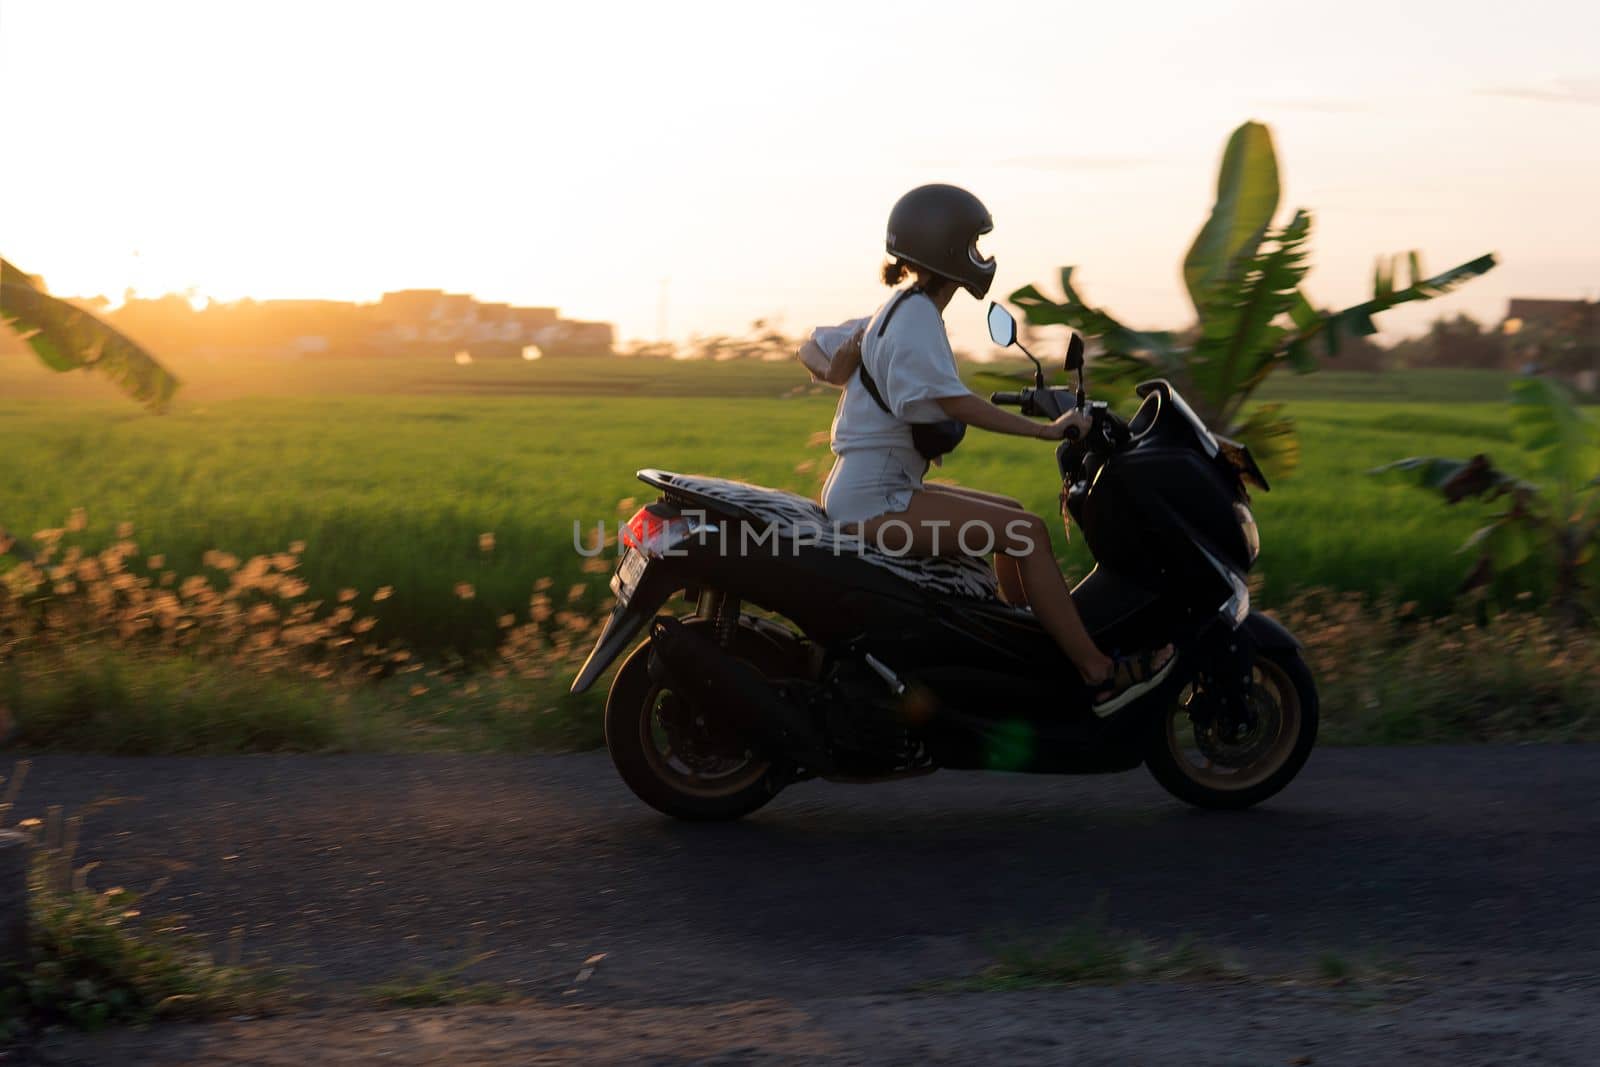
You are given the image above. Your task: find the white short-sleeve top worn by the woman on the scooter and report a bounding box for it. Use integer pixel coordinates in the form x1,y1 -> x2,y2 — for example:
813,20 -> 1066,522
813,291 -> 971,456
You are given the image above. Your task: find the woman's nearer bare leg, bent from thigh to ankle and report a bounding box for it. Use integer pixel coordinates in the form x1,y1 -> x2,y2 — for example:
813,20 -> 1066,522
861,490 -> 1114,683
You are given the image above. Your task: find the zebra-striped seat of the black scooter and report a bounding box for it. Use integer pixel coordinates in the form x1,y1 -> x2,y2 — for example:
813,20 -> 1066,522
638,469 -> 998,600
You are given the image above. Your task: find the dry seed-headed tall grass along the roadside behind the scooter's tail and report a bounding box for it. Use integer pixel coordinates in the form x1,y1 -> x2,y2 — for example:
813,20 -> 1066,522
0,512 -> 598,755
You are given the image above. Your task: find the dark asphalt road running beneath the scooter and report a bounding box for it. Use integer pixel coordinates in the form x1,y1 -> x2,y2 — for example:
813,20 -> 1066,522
16,745 -> 1600,1006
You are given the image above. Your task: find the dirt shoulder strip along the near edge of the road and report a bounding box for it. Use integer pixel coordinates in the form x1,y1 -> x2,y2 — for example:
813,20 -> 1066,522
37,976 -> 1600,1067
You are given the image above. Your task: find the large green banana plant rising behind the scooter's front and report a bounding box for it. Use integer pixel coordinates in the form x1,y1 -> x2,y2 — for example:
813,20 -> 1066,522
1010,122 -> 1494,477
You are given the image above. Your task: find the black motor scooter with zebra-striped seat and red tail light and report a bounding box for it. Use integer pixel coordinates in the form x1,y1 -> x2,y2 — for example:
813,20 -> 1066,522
573,304 -> 1317,819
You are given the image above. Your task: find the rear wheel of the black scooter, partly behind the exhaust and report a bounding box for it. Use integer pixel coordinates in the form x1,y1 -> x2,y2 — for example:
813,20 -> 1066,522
605,619 -> 787,822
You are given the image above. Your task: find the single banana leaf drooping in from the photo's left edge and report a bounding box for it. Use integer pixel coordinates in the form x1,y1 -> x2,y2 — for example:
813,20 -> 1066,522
0,259 -> 179,411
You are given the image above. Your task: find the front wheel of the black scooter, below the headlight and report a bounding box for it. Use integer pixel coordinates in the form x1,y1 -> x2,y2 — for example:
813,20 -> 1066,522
1144,649 -> 1318,809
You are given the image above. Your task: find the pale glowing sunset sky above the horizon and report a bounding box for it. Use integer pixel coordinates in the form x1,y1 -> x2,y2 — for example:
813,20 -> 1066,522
0,0 -> 1600,346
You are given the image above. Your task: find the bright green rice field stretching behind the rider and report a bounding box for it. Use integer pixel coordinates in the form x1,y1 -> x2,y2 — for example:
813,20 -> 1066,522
0,355 -> 1548,651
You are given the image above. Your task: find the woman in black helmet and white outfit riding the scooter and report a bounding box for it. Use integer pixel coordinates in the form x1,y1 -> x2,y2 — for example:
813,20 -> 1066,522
800,186 -> 1173,713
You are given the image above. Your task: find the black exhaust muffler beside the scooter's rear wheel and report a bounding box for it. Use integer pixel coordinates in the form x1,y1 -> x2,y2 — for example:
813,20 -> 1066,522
650,616 -> 827,771
